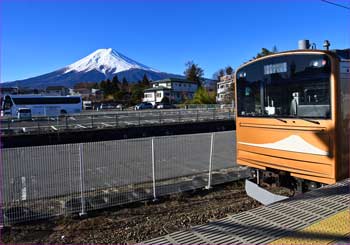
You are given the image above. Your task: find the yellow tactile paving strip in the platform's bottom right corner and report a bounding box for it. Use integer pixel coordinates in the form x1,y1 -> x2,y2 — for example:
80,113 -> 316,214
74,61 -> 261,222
270,209 -> 350,245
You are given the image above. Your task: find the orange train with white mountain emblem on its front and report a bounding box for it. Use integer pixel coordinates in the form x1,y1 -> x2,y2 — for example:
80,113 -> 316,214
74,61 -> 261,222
235,49 -> 350,189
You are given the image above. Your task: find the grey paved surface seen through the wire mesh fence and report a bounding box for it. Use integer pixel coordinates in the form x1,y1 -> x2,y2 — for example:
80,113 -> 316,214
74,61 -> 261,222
2,131 -> 236,202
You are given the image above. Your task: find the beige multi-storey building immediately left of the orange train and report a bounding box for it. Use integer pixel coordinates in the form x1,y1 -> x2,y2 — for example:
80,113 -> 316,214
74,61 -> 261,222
216,75 -> 235,104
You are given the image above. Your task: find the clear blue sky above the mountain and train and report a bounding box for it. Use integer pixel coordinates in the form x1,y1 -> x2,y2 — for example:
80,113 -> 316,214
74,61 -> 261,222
0,0 -> 350,81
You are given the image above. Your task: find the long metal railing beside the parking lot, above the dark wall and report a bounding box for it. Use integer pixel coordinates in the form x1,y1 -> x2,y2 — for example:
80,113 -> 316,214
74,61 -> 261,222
0,109 -> 234,135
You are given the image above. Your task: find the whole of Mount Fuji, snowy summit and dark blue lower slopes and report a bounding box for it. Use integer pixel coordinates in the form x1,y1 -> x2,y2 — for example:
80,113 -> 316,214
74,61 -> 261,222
1,48 -> 183,88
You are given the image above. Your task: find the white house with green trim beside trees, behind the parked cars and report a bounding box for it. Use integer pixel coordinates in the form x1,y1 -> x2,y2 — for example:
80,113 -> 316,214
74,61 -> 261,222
142,78 -> 198,105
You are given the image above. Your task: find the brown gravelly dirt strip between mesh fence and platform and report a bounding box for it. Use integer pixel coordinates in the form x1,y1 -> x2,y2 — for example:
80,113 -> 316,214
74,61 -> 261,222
1,181 -> 260,244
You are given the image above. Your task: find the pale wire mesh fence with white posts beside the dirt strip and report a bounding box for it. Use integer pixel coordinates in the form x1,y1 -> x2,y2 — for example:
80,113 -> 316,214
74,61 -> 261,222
1,131 -> 246,225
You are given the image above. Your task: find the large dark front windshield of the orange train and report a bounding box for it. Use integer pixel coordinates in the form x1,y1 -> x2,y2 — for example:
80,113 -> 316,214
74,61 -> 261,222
236,54 -> 331,119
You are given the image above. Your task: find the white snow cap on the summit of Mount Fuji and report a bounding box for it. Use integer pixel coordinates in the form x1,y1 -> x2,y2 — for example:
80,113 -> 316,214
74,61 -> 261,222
65,48 -> 157,75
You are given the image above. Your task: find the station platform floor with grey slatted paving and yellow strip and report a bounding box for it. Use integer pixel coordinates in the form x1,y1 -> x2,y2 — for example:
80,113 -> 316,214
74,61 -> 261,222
142,179 -> 350,244
